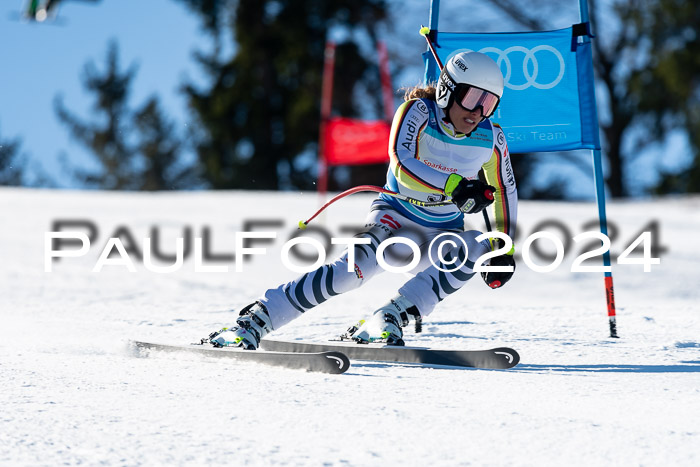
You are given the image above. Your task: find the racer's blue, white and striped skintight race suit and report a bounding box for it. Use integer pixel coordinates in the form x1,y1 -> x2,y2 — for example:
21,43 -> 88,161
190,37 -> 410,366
254,99 -> 517,329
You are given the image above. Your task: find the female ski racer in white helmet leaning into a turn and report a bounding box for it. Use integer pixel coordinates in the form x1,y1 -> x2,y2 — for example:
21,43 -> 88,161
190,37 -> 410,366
203,52 -> 517,349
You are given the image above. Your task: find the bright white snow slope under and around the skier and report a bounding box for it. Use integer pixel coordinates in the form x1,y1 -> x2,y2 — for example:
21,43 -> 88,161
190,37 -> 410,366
0,189 -> 700,466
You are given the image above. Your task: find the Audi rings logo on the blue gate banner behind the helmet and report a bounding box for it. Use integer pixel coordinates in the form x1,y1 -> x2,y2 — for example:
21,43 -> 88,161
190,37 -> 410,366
448,45 -> 566,91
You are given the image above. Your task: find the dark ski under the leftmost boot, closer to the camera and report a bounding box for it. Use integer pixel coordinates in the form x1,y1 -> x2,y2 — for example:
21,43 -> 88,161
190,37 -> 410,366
131,341 -> 350,374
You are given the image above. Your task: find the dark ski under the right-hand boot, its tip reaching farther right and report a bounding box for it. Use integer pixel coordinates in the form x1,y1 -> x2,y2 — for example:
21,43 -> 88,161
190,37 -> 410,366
260,339 -> 520,370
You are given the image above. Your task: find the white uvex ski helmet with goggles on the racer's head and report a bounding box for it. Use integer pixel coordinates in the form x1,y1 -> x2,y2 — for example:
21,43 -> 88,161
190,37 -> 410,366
436,52 -> 503,117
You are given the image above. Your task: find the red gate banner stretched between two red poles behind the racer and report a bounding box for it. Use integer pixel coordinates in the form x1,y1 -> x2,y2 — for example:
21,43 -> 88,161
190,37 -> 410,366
324,118 -> 391,166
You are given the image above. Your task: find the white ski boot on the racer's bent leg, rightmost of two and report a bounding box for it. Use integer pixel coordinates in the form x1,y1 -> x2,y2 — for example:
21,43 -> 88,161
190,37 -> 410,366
341,295 -> 421,346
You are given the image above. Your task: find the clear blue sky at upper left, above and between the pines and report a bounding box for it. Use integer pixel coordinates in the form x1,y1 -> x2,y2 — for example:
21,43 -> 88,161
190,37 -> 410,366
0,0 -> 209,186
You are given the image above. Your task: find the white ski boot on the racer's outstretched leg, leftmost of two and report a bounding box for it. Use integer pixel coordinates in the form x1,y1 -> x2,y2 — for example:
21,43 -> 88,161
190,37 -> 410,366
202,302 -> 272,350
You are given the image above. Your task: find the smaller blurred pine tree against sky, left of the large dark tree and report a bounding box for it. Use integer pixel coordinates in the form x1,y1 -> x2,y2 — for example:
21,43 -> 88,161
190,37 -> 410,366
55,41 -> 197,190
